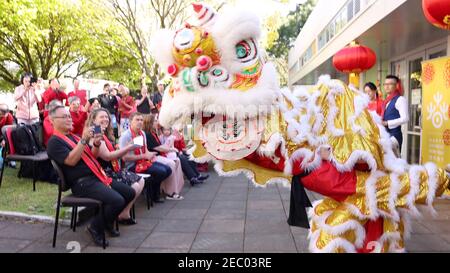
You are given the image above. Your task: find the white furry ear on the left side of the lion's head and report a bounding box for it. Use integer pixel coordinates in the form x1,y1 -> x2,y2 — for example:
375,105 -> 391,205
150,29 -> 175,71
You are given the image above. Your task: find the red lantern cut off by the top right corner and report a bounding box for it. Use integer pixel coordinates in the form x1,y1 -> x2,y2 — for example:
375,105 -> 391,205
422,0 -> 450,30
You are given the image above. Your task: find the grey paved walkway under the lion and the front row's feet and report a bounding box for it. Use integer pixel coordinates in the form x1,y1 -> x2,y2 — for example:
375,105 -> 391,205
0,170 -> 450,253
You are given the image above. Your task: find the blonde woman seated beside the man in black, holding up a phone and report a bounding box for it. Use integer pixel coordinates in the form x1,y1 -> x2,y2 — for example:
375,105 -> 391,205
85,108 -> 145,225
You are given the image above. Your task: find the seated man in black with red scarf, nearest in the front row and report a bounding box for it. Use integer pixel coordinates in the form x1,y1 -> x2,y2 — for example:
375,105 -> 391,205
47,106 -> 135,246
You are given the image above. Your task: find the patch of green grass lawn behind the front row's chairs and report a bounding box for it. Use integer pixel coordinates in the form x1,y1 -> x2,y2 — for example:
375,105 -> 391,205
0,163 -> 70,217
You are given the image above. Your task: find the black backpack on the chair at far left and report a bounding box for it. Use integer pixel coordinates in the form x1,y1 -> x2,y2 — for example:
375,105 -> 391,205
11,125 -> 43,155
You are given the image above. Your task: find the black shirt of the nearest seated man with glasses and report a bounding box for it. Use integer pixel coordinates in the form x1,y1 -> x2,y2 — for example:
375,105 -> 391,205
47,133 -> 95,186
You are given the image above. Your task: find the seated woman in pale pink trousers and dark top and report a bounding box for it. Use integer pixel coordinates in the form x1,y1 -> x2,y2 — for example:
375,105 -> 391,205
143,114 -> 184,200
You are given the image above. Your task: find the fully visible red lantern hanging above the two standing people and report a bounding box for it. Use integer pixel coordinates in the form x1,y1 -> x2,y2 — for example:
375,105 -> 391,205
333,44 -> 377,73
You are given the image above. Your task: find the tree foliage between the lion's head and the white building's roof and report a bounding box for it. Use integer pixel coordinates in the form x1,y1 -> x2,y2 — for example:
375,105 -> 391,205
267,0 -> 316,60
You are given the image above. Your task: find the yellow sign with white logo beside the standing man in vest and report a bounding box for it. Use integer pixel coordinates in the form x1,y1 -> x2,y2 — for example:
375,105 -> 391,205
421,57 -> 450,168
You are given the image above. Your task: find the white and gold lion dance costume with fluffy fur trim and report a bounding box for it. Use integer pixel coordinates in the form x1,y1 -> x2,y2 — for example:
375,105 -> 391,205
152,4 -> 450,252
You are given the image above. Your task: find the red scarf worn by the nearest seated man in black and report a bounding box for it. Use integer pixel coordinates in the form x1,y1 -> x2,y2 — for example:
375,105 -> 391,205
53,131 -> 112,186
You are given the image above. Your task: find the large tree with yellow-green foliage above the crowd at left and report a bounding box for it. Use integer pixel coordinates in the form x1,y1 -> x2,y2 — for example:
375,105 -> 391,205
0,0 -> 137,87
